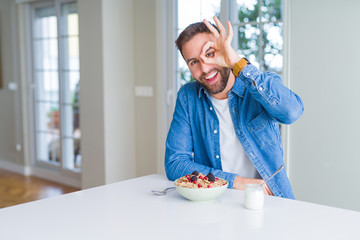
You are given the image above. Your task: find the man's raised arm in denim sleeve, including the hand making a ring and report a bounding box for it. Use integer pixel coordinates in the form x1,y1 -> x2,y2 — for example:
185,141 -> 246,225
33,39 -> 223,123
201,16 -> 304,124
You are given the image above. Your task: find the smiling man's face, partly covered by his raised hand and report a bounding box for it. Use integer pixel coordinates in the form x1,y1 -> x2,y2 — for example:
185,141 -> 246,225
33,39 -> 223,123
182,33 -> 230,95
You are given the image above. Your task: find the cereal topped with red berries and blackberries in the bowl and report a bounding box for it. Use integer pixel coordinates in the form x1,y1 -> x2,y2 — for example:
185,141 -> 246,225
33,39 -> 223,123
175,171 -> 227,188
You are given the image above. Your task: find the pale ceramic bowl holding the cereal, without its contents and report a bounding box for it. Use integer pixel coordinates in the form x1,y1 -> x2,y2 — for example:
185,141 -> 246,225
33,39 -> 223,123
174,178 -> 229,201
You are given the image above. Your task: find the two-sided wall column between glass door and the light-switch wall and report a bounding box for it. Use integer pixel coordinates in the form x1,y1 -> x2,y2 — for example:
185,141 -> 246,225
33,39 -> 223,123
78,0 -> 136,188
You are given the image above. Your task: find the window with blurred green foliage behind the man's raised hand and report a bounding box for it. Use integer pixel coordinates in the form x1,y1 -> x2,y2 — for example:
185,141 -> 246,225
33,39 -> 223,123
233,0 -> 283,74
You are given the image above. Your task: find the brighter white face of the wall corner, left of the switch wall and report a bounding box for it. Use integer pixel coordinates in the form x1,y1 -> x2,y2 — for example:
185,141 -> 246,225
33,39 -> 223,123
102,0 -> 136,183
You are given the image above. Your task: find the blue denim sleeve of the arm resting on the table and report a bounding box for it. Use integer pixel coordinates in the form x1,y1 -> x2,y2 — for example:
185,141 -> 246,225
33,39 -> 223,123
165,89 -> 236,188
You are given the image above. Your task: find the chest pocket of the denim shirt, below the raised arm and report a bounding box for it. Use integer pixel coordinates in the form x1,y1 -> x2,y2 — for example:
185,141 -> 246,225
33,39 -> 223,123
247,111 -> 276,149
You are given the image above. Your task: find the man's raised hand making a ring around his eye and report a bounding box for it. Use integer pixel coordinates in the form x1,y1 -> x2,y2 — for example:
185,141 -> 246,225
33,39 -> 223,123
200,16 -> 241,68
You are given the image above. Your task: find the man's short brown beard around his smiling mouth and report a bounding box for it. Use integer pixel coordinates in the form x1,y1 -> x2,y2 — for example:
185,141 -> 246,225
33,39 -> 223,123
198,68 -> 230,95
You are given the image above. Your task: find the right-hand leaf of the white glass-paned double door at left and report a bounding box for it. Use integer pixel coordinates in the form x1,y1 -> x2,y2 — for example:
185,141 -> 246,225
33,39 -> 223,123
59,3 -> 81,171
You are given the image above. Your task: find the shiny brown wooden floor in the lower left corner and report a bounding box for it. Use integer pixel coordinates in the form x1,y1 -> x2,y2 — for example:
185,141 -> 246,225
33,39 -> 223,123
0,169 -> 80,208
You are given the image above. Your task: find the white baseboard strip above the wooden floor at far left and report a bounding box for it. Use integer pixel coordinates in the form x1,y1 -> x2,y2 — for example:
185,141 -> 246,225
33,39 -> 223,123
0,159 -> 81,188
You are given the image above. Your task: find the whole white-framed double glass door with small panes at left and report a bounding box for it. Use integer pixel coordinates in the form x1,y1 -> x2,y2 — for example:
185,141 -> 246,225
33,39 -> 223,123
31,1 -> 81,172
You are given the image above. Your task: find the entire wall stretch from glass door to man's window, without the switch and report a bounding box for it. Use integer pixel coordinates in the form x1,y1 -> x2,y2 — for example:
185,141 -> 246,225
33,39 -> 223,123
79,0 -> 160,187
